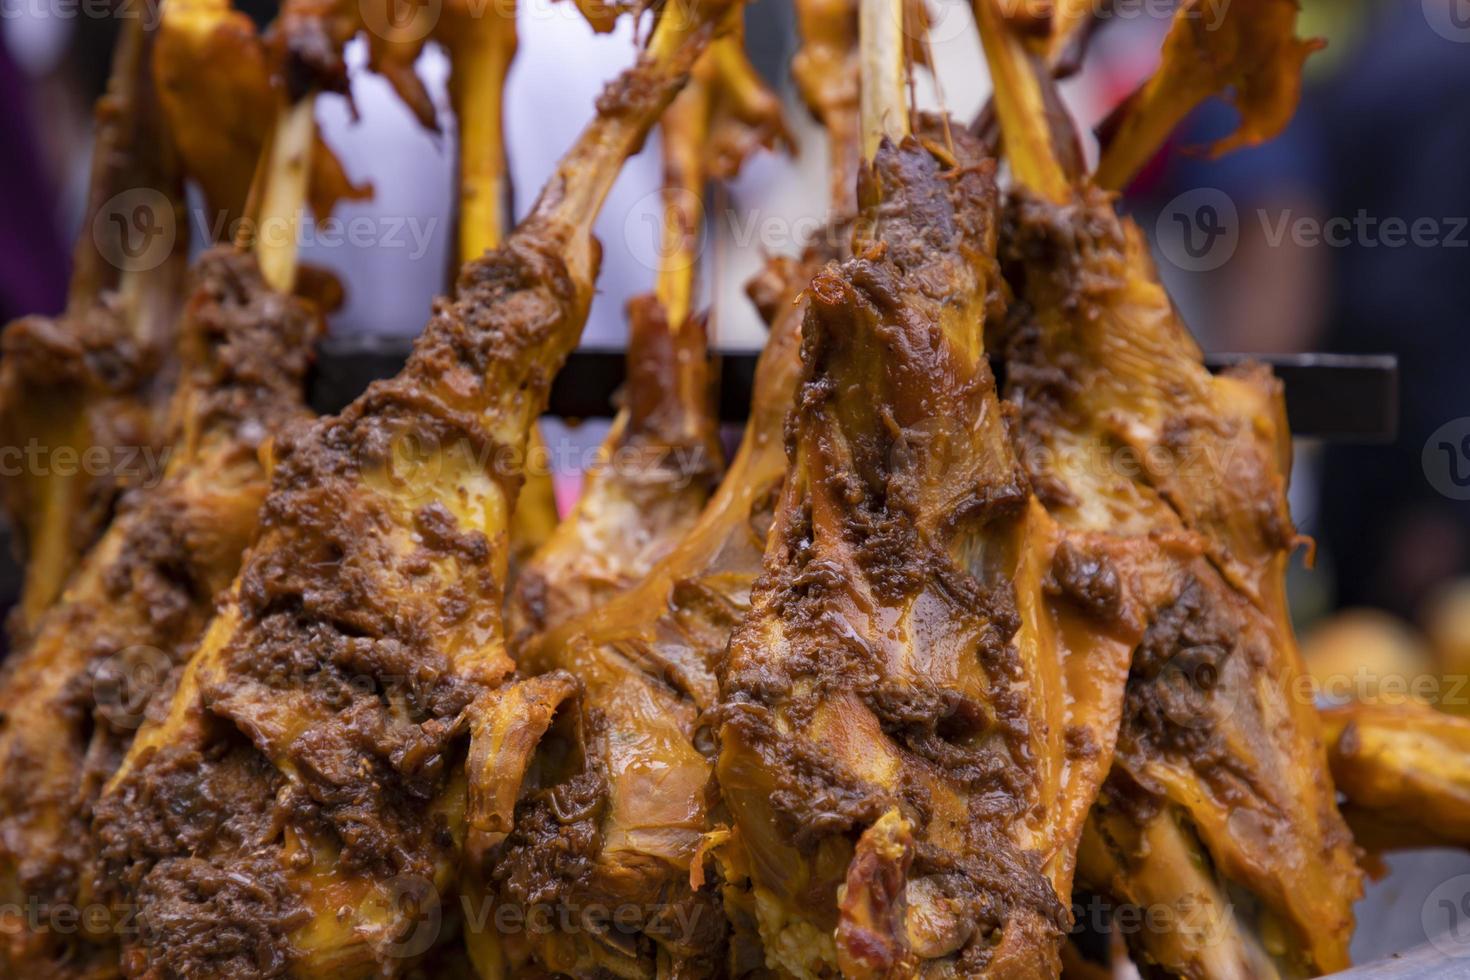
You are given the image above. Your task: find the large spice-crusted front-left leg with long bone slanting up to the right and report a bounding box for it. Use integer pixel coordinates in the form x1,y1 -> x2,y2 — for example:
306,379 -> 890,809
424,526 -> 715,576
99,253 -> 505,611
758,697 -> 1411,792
94,0 -> 728,976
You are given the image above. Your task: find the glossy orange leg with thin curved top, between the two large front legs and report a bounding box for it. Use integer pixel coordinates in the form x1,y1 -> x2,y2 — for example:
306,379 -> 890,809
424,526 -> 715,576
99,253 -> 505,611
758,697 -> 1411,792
487,243 -> 816,977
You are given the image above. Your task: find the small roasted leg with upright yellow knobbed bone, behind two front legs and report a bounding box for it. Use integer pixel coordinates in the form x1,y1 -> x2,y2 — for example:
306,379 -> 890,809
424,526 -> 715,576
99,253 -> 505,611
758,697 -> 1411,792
507,22 -> 785,646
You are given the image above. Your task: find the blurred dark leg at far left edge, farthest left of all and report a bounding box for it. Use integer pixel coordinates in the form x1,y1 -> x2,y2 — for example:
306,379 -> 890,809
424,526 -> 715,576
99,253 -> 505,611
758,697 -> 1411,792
0,18 -> 188,645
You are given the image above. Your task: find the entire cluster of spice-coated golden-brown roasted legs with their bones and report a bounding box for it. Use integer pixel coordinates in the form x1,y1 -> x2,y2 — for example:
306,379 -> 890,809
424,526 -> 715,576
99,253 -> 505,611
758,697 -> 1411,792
0,0 -> 1470,980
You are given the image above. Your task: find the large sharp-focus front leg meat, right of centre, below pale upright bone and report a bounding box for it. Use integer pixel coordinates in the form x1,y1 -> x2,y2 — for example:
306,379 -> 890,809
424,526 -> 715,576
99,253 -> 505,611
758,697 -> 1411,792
719,125 -> 1132,977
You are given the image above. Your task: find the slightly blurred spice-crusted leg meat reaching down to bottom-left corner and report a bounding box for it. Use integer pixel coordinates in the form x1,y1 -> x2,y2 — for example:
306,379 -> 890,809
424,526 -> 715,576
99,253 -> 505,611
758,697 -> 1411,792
0,250 -> 319,977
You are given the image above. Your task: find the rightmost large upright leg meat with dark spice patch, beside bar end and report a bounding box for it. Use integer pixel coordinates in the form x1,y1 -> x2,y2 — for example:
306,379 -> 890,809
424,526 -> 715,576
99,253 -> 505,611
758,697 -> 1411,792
1003,190 -> 1360,976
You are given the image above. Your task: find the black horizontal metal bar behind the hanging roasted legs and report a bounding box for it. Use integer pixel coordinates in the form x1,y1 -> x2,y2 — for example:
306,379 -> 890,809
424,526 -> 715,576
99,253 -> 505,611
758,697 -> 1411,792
312,338 -> 1398,442
